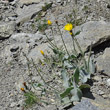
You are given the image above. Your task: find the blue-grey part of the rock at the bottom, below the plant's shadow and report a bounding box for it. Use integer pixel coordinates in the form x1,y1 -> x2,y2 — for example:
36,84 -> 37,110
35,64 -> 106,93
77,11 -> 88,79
70,99 -> 100,110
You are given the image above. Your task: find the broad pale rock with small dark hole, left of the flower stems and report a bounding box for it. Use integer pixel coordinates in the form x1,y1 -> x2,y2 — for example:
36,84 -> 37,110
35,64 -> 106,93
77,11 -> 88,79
0,33 -> 49,64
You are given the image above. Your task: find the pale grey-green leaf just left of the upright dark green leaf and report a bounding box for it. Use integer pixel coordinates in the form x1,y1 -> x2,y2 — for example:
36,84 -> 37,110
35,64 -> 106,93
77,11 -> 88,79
61,70 -> 69,88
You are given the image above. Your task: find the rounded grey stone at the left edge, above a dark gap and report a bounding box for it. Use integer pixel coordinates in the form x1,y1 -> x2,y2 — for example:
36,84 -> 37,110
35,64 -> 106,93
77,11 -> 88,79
0,22 -> 16,39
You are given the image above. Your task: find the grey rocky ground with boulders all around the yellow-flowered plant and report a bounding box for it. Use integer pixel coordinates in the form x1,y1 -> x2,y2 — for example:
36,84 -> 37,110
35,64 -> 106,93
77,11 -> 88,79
0,0 -> 110,110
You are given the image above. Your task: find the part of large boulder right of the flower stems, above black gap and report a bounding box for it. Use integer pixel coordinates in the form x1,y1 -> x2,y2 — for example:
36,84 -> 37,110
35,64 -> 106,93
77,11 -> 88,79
73,21 -> 110,51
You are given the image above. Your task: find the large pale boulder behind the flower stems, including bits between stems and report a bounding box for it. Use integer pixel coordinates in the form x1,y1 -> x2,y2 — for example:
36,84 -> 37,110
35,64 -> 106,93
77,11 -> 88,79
52,21 -> 110,52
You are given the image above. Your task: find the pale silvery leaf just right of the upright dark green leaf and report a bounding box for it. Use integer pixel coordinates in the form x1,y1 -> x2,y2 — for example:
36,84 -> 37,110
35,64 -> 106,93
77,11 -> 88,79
80,68 -> 90,83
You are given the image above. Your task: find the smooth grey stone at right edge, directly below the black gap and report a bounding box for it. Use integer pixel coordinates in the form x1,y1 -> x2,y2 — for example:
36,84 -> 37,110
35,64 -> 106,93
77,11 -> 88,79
95,48 -> 110,76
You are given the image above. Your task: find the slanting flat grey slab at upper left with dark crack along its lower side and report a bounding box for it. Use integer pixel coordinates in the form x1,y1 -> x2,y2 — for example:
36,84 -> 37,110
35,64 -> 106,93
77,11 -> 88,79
16,0 -> 51,24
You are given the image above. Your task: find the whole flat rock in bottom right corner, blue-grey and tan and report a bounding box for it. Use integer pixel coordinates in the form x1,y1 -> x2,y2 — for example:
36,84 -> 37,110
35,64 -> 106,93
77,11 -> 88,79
69,94 -> 110,110
